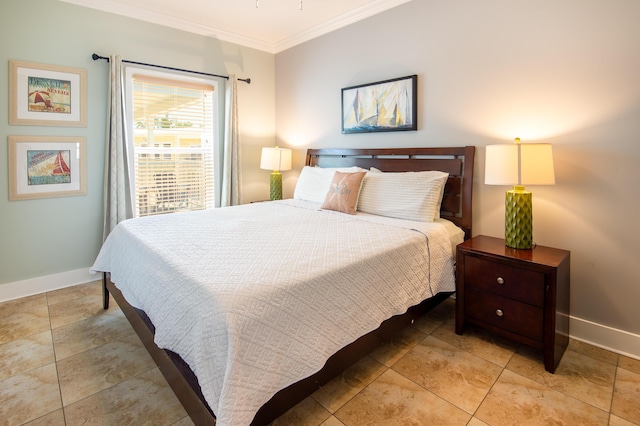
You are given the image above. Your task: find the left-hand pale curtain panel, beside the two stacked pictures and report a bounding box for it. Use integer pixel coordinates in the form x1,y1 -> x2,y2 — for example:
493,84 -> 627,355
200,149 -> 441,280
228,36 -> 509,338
102,55 -> 133,240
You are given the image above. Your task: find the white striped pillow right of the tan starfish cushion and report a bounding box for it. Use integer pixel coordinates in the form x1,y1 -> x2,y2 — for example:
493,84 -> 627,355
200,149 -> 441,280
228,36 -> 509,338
358,171 -> 449,222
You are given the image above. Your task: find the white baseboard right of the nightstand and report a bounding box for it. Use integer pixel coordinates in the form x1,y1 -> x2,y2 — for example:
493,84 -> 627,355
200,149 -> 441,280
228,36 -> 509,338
569,316 -> 640,360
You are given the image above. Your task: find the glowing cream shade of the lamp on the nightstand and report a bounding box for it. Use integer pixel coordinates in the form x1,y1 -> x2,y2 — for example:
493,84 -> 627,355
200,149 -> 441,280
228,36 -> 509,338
484,143 -> 556,185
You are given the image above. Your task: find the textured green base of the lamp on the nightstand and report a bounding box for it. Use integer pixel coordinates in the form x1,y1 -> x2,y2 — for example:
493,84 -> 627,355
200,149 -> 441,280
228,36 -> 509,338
504,185 -> 533,249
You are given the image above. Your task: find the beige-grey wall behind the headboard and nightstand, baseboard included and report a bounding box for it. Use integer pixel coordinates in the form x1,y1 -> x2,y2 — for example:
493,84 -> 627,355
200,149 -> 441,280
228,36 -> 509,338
276,0 -> 640,357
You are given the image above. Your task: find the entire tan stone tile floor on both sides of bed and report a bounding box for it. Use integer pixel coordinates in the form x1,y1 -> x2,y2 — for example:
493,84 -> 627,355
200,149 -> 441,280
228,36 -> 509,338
0,281 -> 640,426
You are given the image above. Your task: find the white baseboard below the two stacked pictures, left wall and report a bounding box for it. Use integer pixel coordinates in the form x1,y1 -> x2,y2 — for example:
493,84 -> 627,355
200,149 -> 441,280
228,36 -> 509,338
0,266 -> 102,302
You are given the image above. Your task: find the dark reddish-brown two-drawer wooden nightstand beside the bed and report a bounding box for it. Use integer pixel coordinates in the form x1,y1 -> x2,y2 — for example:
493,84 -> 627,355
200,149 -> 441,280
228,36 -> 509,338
456,235 -> 571,373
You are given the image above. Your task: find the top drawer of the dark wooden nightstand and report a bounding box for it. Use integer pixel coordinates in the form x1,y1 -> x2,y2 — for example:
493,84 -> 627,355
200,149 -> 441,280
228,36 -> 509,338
464,256 -> 544,307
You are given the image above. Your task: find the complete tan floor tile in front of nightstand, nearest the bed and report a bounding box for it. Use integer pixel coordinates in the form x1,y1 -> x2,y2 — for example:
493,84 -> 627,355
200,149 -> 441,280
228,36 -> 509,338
392,336 -> 502,414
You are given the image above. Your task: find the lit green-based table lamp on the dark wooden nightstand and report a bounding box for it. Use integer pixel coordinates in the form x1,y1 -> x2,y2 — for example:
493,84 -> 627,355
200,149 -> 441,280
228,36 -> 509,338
484,138 -> 555,249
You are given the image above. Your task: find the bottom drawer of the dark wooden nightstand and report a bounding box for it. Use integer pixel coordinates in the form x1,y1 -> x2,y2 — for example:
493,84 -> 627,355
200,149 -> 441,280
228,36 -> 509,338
464,287 -> 543,342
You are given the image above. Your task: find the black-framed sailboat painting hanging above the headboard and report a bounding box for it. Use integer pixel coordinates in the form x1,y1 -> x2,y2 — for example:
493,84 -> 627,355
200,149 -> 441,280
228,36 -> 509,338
342,75 -> 418,133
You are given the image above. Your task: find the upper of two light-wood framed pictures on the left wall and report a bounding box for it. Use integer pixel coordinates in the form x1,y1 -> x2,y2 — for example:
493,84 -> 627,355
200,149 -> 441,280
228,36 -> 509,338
9,60 -> 87,127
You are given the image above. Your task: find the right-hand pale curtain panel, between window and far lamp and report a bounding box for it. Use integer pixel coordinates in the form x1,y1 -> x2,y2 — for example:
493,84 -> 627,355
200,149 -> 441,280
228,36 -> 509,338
220,74 -> 242,207
